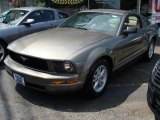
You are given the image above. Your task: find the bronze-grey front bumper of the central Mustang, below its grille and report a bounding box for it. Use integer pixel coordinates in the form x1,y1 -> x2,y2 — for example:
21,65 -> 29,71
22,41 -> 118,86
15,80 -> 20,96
4,56 -> 83,92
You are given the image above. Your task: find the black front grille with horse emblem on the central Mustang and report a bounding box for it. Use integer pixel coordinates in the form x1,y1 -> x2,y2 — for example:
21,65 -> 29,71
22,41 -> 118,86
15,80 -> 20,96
9,51 -> 49,72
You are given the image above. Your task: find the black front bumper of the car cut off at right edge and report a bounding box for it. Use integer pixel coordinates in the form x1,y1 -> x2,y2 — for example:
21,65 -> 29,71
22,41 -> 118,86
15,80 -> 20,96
147,84 -> 160,119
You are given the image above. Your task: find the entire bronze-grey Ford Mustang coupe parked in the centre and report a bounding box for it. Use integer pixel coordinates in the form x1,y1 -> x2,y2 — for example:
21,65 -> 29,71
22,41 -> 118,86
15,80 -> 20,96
4,9 -> 158,97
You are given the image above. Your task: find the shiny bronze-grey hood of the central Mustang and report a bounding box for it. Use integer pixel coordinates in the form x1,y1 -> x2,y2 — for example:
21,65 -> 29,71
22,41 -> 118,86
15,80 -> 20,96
8,28 -> 112,60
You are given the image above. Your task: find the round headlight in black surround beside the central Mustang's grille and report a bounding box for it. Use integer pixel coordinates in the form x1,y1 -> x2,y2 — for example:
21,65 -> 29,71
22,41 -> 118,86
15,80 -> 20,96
53,61 -> 76,74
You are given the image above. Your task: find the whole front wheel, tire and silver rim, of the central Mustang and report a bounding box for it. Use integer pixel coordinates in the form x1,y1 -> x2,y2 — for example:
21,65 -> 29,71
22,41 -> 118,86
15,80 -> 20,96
84,59 -> 111,98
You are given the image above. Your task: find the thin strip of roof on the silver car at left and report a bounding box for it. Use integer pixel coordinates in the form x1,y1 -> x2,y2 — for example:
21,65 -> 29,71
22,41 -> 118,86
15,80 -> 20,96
11,7 -> 68,13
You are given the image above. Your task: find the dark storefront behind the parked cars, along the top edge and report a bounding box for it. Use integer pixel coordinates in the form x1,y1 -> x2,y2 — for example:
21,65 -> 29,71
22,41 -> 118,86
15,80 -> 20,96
0,0 -> 152,16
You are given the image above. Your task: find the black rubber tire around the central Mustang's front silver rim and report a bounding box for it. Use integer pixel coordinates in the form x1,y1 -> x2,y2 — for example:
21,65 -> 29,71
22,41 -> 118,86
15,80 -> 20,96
84,59 -> 111,98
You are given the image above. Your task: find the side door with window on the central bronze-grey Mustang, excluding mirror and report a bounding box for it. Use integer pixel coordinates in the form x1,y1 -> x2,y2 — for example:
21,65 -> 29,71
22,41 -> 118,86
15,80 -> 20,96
115,15 -> 144,65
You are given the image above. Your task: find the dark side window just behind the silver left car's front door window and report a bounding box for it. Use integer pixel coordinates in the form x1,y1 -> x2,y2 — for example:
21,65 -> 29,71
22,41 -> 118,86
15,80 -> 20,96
42,10 -> 55,21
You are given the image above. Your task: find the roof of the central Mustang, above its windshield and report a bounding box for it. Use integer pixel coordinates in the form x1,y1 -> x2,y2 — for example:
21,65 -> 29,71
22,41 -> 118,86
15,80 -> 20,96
81,9 -> 130,15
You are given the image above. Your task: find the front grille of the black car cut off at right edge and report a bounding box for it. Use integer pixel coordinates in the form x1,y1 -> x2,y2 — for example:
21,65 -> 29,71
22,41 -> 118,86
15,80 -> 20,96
152,60 -> 160,88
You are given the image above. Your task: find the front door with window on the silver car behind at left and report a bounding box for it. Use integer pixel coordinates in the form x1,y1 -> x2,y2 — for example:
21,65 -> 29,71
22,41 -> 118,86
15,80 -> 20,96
20,10 -> 50,37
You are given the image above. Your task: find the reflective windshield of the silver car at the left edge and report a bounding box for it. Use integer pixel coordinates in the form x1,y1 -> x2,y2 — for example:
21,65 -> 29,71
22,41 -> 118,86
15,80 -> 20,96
0,10 -> 28,25
